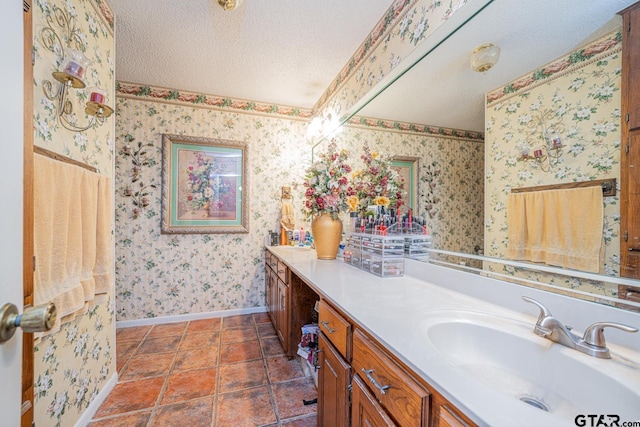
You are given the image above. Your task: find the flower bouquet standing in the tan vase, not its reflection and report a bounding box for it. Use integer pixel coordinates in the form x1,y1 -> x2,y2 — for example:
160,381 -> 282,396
303,142 -> 351,219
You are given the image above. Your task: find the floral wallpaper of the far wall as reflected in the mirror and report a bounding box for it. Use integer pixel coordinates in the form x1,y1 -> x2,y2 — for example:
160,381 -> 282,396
335,126 -> 484,253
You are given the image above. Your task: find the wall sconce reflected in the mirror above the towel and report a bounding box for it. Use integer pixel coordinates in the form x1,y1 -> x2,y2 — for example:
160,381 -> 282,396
518,109 -> 566,172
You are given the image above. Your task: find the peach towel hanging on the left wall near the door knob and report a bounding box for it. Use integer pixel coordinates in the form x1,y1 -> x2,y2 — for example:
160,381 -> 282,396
34,154 -> 112,338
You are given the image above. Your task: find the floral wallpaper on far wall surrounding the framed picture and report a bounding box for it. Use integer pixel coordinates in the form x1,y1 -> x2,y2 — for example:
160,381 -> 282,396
115,98 -> 311,320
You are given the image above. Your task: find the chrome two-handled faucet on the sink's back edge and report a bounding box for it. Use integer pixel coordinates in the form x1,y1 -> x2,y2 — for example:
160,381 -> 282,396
522,296 -> 638,359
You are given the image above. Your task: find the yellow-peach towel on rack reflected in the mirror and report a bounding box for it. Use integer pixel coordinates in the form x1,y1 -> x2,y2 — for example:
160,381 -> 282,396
507,186 -> 604,273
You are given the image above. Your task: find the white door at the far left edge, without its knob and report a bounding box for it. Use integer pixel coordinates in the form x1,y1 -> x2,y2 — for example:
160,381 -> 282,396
0,0 -> 23,426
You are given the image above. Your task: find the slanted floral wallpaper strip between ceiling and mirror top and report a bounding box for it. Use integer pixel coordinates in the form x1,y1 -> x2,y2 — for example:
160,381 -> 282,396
313,0 -> 468,115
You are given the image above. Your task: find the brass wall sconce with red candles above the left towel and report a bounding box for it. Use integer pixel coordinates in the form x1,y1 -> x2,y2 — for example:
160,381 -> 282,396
40,6 -> 113,132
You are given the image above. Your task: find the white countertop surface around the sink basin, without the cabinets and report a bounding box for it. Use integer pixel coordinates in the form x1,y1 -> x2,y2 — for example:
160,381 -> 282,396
267,246 -> 640,427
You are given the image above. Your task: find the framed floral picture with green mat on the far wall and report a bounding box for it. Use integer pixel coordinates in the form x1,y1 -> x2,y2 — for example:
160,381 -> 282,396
161,134 -> 249,234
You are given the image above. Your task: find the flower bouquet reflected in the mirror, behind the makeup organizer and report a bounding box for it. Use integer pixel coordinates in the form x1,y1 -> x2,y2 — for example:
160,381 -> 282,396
347,143 -> 403,216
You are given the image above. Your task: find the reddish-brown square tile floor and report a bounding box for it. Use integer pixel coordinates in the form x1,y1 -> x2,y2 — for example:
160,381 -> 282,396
89,313 -> 317,427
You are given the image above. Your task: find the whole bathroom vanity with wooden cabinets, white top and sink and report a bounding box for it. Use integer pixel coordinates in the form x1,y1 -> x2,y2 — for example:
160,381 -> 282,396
265,247 -> 640,427
